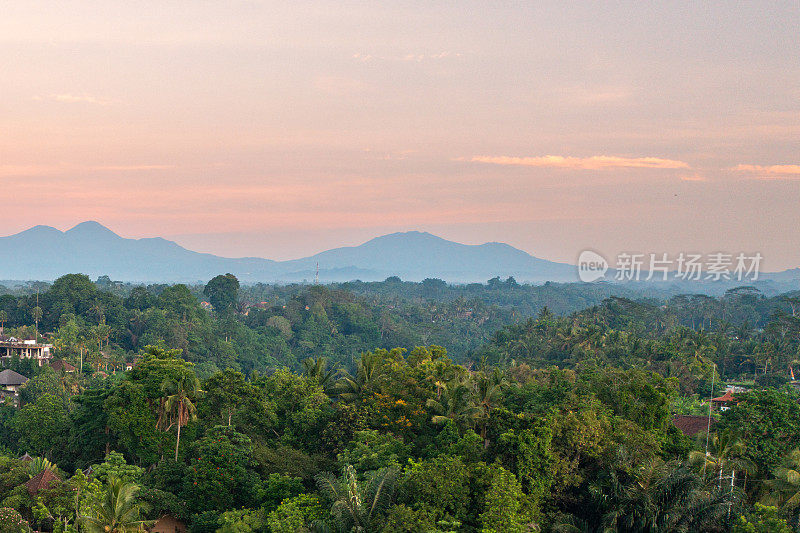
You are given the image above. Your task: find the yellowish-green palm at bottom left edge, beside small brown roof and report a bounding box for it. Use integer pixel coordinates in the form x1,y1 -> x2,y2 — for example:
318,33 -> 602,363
80,476 -> 152,533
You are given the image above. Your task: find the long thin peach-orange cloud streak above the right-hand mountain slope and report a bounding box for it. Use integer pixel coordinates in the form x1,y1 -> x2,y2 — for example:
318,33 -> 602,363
470,155 -> 689,170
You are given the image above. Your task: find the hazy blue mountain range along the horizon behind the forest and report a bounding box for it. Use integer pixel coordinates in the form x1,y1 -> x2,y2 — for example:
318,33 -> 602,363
0,221 -> 577,283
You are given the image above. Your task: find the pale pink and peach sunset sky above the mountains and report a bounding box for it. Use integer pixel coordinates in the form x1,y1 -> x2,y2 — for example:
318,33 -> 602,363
0,0 -> 800,270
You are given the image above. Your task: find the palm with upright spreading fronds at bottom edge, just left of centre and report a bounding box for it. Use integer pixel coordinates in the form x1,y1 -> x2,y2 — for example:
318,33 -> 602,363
317,465 -> 398,532
